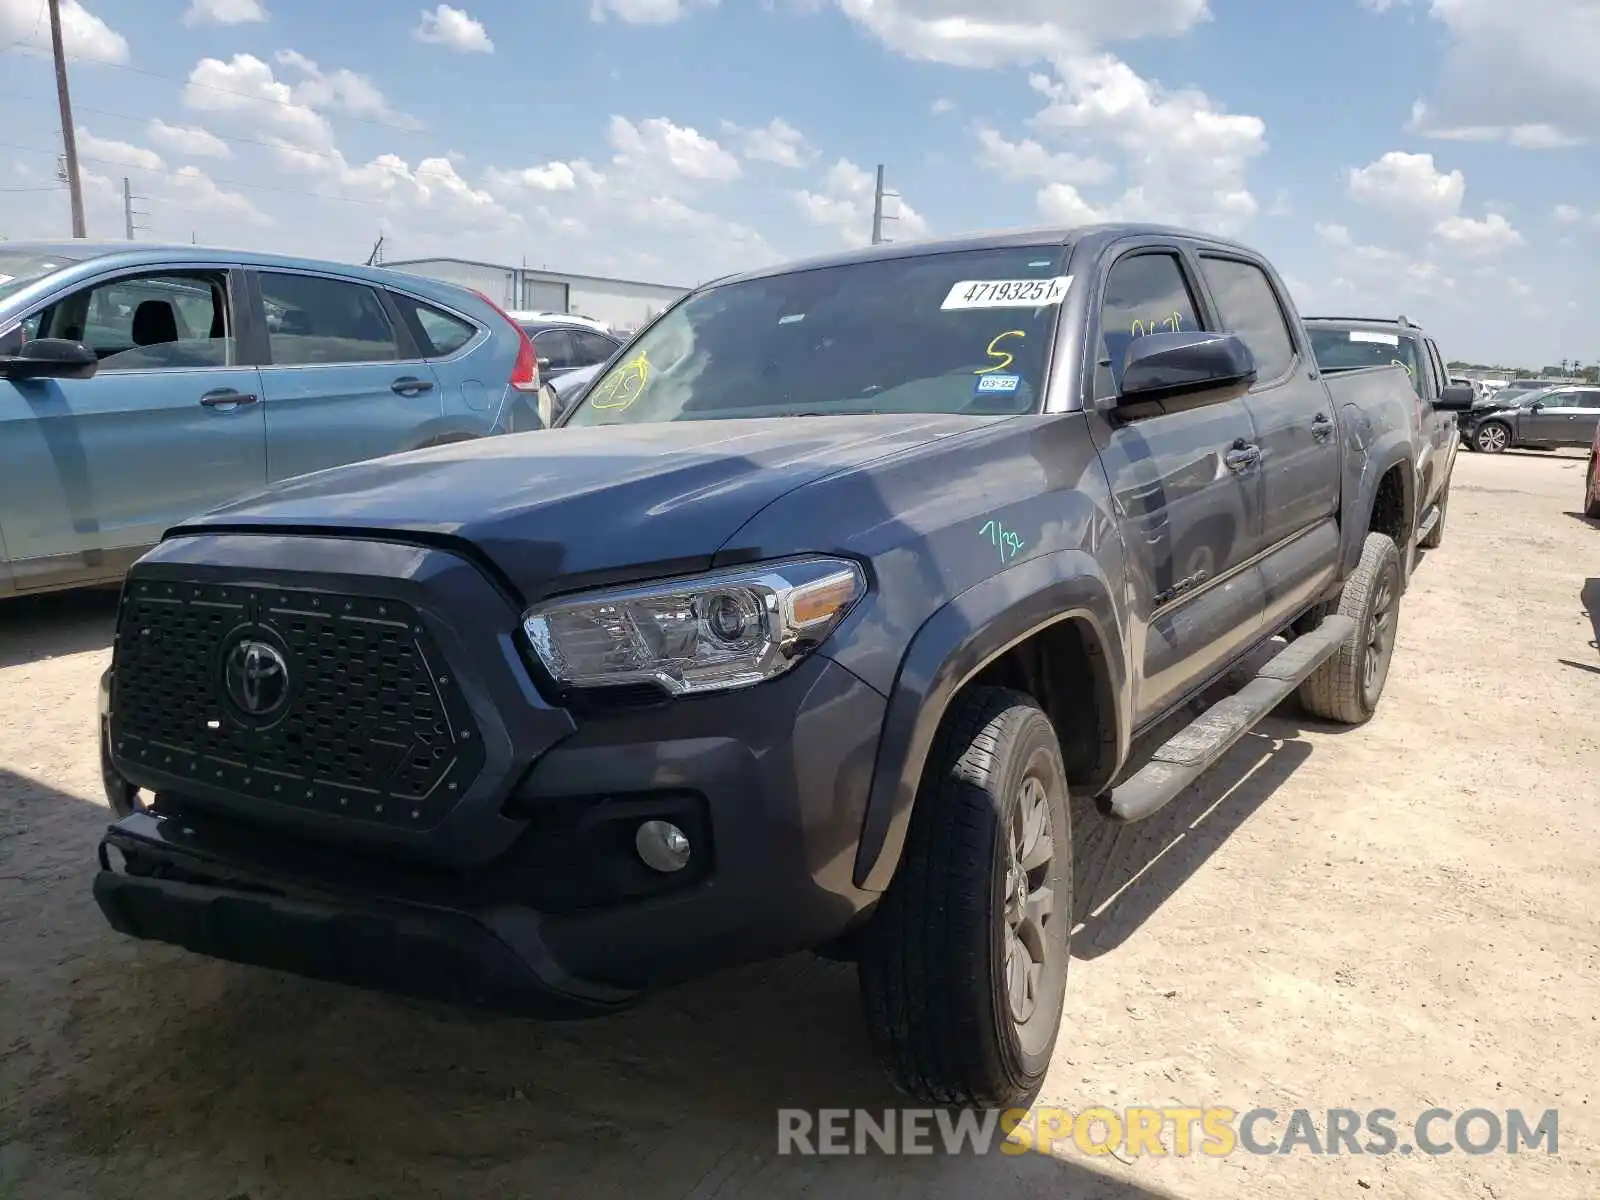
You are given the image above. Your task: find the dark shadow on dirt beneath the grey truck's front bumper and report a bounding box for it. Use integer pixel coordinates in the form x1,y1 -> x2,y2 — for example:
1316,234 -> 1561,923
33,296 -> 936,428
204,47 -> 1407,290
0,770 -> 1173,1200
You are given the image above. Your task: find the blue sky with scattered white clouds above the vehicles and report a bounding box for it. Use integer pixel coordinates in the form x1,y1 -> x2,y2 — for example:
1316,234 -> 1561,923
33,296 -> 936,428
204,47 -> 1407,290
0,0 -> 1600,366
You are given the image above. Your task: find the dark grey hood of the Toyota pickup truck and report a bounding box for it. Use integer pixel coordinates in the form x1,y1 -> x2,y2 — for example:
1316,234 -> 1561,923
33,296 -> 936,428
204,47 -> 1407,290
181,413 -> 1006,602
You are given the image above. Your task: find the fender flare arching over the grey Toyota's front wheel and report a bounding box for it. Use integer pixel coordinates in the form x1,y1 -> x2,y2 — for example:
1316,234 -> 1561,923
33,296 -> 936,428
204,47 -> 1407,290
854,550 -> 1128,891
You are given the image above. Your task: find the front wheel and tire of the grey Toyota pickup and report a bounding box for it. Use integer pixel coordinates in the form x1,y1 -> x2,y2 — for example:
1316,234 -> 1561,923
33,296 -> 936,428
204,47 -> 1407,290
859,688 -> 1072,1107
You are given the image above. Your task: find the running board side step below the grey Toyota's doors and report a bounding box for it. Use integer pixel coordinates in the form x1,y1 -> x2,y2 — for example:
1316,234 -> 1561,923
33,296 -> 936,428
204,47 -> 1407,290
1094,614 -> 1355,824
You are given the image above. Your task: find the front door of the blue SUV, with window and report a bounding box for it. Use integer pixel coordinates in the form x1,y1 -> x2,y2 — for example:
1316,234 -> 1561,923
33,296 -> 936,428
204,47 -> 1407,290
0,267 -> 266,590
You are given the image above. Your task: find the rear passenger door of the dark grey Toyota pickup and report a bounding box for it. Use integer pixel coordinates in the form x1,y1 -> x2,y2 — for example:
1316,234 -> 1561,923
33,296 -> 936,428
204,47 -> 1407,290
1198,250 -> 1342,630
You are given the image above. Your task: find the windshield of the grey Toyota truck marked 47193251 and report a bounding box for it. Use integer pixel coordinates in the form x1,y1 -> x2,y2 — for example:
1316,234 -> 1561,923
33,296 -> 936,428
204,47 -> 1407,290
566,246 -> 1070,426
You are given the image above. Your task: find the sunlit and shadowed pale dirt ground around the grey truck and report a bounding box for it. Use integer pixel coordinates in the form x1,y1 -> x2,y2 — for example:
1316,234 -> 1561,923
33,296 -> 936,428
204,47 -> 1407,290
0,453 -> 1600,1200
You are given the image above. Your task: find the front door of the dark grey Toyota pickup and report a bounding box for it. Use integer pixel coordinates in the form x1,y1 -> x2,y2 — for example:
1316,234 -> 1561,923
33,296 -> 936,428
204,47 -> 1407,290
1091,246 -> 1261,723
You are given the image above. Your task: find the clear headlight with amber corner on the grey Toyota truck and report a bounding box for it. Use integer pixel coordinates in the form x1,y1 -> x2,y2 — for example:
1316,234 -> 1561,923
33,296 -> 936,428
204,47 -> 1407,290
522,557 -> 867,696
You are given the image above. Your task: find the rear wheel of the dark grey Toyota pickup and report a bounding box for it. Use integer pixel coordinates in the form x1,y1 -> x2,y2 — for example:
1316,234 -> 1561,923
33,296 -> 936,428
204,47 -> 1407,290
1299,533 -> 1402,725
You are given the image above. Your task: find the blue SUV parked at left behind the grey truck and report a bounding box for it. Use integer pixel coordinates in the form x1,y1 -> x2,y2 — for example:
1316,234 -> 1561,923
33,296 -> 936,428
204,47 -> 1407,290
0,242 -> 539,597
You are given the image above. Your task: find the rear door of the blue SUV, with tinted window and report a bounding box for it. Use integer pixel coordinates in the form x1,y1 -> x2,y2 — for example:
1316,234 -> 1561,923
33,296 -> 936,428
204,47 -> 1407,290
256,269 -> 442,480
